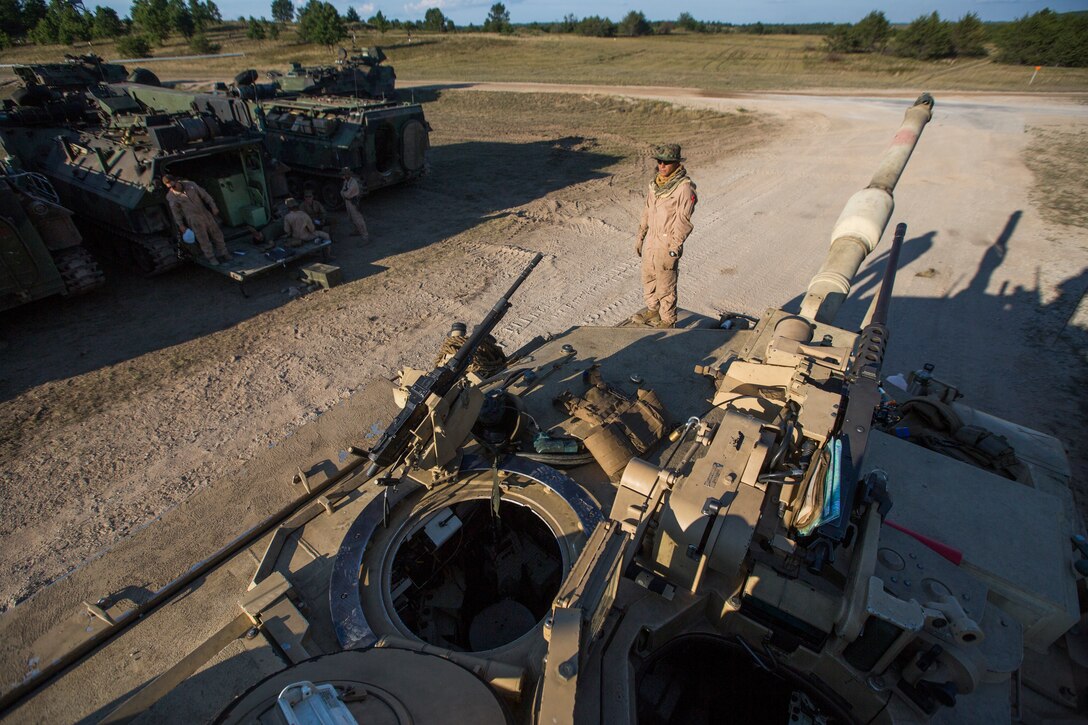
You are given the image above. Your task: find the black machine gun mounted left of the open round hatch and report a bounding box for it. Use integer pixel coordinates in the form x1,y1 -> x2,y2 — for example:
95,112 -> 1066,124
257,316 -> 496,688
367,253 -> 544,478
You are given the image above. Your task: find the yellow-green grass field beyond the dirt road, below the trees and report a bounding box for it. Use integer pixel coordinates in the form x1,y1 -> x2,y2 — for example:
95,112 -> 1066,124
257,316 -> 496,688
0,27 -> 1088,93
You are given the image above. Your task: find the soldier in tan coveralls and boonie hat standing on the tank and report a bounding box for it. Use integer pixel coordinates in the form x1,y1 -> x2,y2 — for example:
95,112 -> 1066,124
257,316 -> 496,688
631,144 -> 697,328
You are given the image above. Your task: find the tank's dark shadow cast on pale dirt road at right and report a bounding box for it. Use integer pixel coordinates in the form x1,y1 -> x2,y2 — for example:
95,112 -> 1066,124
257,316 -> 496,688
784,210 -> 1088,492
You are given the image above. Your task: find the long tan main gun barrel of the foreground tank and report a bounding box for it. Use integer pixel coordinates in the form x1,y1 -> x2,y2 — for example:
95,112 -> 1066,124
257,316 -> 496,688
801,94 -> 934,322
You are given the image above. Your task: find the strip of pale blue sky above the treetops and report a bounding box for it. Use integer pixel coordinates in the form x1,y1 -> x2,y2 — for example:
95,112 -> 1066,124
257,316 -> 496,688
95,0 -> 1088,25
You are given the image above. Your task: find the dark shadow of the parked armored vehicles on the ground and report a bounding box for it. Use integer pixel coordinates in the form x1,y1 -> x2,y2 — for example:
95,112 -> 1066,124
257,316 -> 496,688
0,132 -> 617,401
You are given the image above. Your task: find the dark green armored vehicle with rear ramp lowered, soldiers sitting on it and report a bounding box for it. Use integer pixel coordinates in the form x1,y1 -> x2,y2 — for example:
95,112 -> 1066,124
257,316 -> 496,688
0,84 -> 285,274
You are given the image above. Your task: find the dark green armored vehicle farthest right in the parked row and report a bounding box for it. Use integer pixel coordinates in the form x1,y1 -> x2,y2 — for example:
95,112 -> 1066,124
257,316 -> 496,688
128,85 -> 431,209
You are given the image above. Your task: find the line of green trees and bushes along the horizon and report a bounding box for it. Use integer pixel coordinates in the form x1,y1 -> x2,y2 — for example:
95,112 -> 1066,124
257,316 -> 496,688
0,0 -> 1088,66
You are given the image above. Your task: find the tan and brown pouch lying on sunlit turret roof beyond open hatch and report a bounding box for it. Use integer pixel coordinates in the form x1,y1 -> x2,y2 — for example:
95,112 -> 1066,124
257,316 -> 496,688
556,366 -> 668,477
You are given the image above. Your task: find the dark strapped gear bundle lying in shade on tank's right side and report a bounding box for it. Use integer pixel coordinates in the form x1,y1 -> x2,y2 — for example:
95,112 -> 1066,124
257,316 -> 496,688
895,397 -> 1025,480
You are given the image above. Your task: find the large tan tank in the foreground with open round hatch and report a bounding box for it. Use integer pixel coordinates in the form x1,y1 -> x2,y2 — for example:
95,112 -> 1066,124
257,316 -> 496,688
2,96 -> 1088,724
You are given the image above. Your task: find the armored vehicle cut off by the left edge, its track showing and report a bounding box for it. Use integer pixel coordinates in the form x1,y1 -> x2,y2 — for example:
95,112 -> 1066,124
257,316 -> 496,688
0,170 -> 106,310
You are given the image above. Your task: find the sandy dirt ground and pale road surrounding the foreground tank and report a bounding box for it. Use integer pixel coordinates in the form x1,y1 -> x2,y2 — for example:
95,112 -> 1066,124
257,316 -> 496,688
0,84 -> 1088,622
